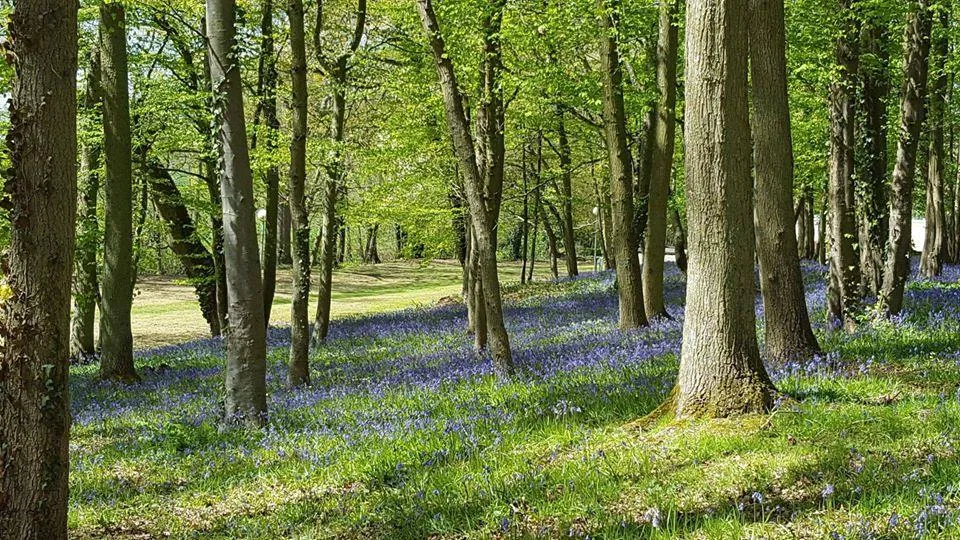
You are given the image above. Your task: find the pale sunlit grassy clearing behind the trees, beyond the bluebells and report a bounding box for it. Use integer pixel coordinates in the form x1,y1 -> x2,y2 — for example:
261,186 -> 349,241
133,260 -> 550,350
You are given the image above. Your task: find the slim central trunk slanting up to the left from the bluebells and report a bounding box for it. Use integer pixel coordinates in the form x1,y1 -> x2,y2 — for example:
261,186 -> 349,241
417,0 -> 514,374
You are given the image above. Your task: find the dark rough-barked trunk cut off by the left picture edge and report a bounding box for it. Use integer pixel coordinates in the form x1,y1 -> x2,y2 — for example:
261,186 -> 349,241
0,0 -> 78,538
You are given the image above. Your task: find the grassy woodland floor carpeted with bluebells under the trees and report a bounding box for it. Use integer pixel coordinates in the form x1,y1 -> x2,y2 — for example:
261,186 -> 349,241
70,264 -> 960,540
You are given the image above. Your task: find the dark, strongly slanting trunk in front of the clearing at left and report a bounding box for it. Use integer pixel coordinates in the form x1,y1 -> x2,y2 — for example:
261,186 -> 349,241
137,155 -> 220,336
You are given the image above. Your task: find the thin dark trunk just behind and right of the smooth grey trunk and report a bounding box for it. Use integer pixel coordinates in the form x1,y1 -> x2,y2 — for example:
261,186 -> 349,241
259,0 -> 280,328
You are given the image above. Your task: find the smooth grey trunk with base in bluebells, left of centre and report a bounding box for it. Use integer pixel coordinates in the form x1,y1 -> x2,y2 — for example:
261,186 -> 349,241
206,0 -> 267,426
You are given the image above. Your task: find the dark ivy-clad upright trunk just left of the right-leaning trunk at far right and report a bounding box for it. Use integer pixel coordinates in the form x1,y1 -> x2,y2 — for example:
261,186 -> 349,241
857,23 -> 890,295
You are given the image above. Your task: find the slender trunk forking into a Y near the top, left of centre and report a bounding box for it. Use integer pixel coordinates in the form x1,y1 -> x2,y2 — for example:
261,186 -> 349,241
313,0 -> 367,344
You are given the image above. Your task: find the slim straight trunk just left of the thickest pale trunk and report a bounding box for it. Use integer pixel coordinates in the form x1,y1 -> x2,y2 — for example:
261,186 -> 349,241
642,0 -> 680,319
